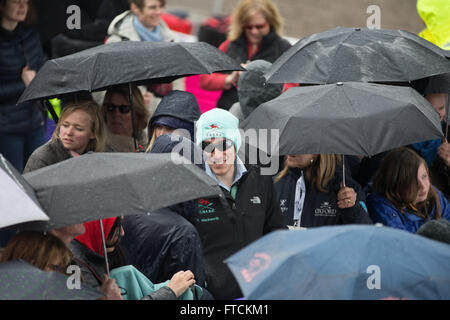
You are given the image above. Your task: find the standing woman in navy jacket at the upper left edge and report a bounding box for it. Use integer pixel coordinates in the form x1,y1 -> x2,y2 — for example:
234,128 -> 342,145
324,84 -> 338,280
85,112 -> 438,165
0,0 -> 46,172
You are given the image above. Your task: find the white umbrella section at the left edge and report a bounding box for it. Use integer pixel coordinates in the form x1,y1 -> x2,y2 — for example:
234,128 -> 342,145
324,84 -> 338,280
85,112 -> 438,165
0,154 -> 49,229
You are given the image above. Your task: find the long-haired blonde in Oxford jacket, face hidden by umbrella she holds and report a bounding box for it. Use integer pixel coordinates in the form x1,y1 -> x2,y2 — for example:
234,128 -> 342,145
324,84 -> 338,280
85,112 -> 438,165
275,154 -> 372,228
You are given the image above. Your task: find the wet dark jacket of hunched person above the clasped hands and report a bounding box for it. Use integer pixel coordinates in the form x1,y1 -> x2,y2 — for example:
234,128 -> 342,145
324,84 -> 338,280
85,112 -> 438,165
122,208 -> 205,286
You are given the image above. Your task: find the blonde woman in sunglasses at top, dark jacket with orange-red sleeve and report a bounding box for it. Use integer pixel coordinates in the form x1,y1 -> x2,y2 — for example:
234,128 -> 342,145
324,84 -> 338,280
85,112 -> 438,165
200,0 -> 291,110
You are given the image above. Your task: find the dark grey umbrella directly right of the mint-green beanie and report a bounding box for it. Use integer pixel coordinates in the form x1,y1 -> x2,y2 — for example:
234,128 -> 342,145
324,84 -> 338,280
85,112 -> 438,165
241,82 -> 443,156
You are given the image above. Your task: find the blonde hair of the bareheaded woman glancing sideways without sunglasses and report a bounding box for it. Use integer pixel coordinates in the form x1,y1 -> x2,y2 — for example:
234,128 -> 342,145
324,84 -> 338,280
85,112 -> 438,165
52,101 -> 106,152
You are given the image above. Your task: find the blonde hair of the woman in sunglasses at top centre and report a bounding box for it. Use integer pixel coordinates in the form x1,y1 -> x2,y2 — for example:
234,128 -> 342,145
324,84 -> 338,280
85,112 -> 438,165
228,0 -> 283,41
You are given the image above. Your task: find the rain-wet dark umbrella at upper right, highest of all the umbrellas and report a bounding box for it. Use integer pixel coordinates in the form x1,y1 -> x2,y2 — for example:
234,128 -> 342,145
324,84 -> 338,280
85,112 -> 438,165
265,27 -> 450,84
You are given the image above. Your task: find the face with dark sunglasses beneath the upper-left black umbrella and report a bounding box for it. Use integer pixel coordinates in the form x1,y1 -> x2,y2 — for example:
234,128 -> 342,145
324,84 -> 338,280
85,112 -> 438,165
103,93 -> 133,137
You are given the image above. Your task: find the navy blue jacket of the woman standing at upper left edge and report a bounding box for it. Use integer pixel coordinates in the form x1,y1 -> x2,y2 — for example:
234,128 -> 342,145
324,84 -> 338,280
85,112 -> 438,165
0,24 -> 44,133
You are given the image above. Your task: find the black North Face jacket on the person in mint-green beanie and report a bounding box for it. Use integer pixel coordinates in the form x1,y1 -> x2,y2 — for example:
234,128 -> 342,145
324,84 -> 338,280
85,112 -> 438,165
195,166 -> 286,299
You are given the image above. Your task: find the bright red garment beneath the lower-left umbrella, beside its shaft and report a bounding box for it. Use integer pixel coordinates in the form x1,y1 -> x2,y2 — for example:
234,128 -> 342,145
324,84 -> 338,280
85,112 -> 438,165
75,218 -> 116,256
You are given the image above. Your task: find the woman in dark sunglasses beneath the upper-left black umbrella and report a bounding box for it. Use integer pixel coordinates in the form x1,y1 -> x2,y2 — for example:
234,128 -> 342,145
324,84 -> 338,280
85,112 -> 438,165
102,85 -> 150,152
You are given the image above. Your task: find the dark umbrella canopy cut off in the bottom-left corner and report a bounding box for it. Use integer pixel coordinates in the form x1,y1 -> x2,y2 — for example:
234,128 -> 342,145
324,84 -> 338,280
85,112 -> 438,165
0,260 -> 104,300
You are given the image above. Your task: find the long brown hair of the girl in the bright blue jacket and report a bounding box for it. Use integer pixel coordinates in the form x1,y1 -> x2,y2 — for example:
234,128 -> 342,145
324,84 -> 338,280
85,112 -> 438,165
373,147 -> 441,219
